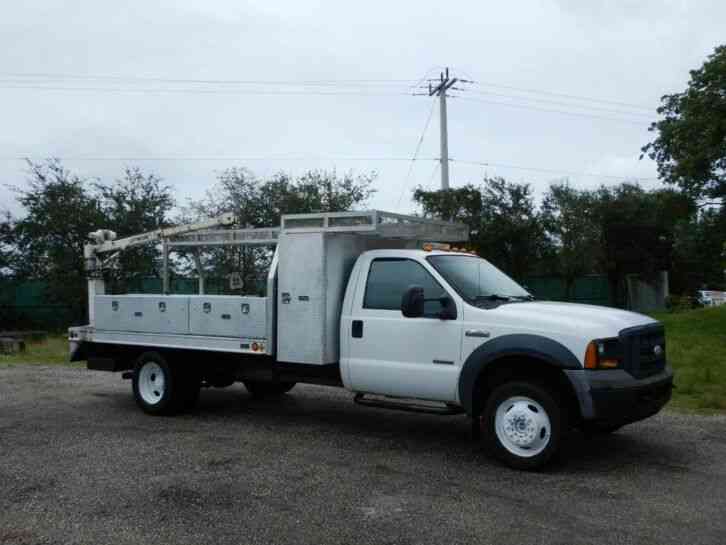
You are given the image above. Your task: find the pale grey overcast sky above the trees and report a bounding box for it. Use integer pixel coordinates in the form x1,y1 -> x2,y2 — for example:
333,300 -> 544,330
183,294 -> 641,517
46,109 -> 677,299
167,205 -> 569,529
0,0 -> 726,217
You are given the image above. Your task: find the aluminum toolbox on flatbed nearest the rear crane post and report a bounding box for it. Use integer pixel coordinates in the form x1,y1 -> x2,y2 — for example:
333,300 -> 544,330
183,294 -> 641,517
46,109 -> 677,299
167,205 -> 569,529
94,295 -> 189,334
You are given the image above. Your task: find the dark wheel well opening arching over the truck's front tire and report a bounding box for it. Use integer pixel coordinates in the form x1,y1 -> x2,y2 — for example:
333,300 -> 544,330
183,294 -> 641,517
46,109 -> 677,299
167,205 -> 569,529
472,356 -> 581,424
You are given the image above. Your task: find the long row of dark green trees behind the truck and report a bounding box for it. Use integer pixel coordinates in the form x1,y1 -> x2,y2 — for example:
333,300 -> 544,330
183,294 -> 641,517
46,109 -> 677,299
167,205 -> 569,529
0,160 -> 726,317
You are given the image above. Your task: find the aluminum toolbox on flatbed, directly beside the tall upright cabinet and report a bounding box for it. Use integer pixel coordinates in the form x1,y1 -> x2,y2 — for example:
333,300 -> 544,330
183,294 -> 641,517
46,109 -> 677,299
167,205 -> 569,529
189,295 -> 267,339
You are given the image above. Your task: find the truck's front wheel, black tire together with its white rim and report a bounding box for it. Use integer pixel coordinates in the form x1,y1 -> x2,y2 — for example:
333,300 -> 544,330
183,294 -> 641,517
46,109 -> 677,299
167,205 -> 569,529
480,381 -> 565,471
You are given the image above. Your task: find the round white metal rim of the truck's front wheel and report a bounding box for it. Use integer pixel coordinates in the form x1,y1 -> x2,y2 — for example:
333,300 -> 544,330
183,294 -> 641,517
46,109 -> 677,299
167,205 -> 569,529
494,396 -> 552,458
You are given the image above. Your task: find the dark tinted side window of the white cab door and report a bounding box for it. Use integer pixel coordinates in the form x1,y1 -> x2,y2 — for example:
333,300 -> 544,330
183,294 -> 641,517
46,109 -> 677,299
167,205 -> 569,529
363,258 -> 447,316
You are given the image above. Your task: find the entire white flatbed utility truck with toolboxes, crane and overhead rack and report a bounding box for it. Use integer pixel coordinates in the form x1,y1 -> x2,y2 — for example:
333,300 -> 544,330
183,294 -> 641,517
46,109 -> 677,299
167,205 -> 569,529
69,210 -> 673,469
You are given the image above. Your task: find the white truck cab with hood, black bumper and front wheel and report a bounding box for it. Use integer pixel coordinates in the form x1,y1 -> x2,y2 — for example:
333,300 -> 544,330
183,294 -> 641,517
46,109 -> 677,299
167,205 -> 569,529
340,250 -> 673,468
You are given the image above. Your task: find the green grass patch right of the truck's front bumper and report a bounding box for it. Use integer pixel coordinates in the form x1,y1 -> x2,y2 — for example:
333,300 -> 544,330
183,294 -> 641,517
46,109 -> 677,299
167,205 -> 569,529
653,305 -> 726,412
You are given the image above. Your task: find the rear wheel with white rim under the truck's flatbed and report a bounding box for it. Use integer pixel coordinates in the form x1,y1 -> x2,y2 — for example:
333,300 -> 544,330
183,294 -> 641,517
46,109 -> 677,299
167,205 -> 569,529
131,352 -> 200,415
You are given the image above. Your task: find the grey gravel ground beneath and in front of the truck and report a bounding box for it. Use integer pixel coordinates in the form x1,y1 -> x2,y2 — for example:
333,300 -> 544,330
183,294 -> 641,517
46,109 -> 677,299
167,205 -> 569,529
0,365 -> 726,545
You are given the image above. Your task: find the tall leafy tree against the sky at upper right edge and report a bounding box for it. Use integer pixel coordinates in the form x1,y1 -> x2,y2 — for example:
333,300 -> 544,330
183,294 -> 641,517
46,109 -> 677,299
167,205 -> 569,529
641,45 -> 726,202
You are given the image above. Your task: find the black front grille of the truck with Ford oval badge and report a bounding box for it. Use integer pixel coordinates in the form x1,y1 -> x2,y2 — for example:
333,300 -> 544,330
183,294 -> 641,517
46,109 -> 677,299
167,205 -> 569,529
620,324 -> 666,378
